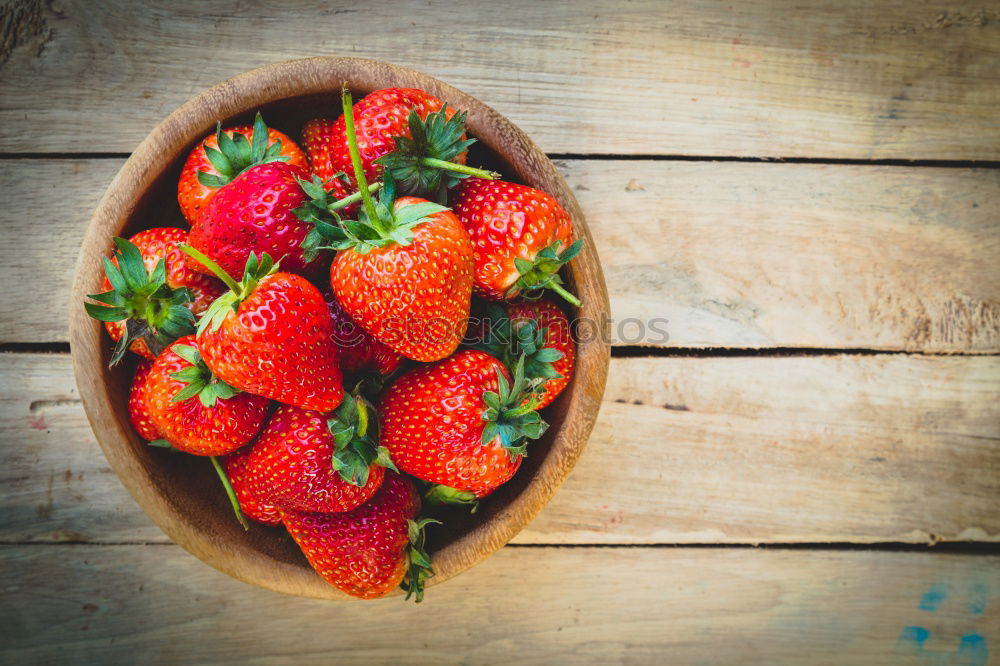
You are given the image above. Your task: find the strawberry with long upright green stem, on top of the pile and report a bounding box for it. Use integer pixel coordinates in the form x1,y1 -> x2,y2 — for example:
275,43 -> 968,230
317,91 -> 473,361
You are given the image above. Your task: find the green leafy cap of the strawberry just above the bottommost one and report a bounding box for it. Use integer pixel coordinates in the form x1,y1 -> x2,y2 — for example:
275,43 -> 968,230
326,393 -> 399,487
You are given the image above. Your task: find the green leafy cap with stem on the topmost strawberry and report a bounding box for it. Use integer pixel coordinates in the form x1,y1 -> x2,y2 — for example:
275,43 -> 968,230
375,104 -> 500,202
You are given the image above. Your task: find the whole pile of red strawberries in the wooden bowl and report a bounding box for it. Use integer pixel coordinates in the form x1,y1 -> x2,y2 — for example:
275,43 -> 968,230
86,88 -> 580,601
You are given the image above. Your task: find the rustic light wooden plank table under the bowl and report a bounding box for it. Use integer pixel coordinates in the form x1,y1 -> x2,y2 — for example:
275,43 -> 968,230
0,0 -> 1000,664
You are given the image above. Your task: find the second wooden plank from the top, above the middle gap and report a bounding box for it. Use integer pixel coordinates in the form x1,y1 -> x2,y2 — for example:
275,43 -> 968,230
0,159 -> 1000,353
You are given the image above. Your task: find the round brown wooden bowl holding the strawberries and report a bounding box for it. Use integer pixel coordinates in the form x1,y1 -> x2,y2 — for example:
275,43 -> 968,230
70,58 -> 609,599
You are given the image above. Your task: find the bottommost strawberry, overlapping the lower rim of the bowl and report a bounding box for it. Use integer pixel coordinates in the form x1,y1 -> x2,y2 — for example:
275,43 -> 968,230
282,472 -> 437,601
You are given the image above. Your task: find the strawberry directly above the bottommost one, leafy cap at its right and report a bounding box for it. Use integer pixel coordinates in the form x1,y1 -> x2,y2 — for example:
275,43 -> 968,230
247,395 -> 392,513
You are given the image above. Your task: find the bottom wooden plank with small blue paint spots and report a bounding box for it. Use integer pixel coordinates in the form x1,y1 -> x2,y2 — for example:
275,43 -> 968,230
0,546 -> 1000,666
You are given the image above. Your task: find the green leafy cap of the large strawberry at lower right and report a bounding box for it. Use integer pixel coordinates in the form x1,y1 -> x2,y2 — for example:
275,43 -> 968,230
482,355 -> 549,460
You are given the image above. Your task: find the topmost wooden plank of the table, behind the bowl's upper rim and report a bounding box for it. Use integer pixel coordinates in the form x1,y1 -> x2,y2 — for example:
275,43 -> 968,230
0,0 -> 1000,160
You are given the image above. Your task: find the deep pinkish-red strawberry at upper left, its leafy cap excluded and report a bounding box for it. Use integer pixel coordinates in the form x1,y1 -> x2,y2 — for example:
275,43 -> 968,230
190,162 -> 319,275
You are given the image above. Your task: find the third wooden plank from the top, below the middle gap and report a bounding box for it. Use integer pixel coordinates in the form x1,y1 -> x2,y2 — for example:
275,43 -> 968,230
0,354 -> 1000,544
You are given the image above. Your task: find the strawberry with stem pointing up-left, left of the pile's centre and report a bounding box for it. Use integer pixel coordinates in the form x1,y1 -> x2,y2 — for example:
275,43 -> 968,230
183,246 -> 344,411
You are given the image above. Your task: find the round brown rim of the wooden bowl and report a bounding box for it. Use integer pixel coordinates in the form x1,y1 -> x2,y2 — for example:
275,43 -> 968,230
69,56 -> 610,599
